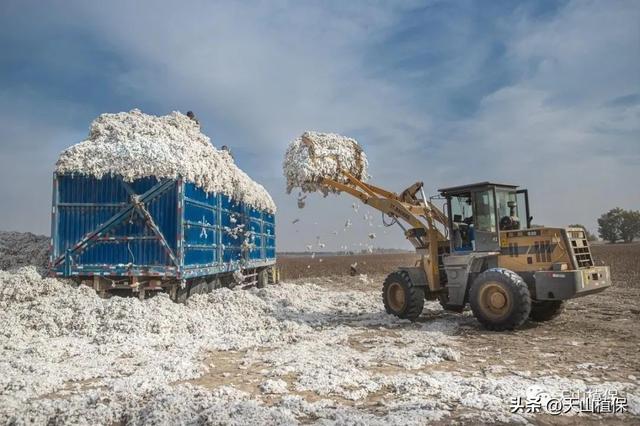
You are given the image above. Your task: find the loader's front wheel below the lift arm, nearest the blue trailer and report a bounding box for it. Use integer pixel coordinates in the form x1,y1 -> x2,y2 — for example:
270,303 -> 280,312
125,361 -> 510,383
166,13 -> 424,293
382,271 -> 424,321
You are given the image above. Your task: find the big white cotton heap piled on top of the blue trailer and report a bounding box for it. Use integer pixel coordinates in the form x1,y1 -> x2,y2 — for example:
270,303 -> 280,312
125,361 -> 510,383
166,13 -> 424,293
56,109 -> 276,212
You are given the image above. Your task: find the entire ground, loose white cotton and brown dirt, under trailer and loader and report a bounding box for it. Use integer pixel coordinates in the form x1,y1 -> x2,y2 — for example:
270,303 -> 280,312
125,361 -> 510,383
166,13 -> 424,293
0,244 -> 640,425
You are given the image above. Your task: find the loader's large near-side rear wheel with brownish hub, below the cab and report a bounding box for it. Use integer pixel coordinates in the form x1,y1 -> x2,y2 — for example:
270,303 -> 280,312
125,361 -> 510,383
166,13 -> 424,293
469,268 -> 531,331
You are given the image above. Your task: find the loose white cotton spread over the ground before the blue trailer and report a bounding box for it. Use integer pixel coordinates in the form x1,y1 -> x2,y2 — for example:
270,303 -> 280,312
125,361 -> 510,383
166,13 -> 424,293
0,267 -> 640,425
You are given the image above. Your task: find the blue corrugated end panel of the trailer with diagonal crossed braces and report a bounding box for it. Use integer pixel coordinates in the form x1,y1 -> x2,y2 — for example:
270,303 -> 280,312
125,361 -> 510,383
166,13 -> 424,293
51,175 -> 178,276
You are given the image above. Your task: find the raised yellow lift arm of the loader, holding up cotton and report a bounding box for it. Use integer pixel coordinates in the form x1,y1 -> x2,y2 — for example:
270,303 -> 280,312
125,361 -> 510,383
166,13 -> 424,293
320,170 -> 448,292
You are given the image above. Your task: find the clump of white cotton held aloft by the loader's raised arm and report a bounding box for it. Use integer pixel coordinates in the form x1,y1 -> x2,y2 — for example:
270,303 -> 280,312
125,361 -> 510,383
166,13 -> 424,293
282,132 -> 369,195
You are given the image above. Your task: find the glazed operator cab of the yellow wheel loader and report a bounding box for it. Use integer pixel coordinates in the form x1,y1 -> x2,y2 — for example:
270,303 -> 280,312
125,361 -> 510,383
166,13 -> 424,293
438,182 -> 531,252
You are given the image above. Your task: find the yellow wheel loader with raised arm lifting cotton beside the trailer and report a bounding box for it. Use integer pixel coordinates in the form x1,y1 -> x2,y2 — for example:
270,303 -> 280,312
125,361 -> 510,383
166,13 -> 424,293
320,171 -> 611,331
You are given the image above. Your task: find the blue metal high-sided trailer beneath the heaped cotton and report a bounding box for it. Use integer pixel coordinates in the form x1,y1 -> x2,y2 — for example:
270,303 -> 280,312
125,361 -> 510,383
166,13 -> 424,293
50,174 -> 278,300
